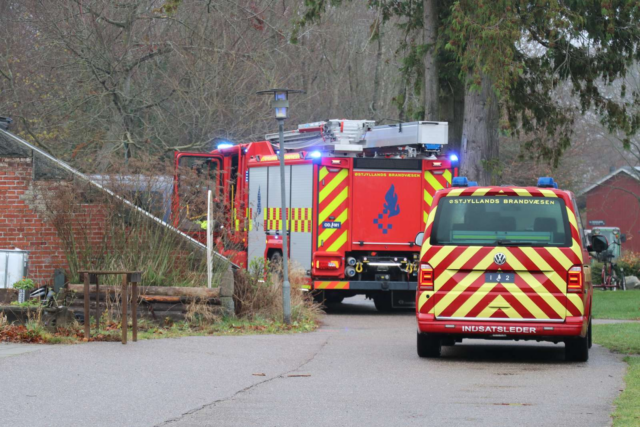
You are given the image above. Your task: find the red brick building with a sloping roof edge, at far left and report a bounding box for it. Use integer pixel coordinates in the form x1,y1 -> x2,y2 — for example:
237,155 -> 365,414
0,128 -> 215,284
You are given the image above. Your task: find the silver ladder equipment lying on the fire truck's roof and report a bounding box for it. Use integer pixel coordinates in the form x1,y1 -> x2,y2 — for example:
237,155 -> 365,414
265,119 -> 449,154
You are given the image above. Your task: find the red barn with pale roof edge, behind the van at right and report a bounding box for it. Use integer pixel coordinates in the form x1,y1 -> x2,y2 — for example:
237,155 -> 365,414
580,167 -> 640,252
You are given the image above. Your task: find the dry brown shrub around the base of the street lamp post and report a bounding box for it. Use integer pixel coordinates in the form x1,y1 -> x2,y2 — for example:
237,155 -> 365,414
234,259 -> 322,322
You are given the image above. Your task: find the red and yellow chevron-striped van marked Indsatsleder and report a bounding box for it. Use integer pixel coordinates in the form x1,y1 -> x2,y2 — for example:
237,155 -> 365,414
416,177 -> 608,361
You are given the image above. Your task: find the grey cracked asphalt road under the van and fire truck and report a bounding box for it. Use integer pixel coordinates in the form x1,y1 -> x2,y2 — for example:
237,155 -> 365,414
0,299 -> 625,427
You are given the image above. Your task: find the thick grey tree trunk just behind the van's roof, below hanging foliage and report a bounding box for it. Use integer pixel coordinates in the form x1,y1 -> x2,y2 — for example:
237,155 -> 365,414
460,75 -> 500,185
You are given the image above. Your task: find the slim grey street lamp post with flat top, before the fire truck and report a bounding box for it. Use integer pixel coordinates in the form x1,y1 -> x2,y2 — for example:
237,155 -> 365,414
258,89 -> 304,325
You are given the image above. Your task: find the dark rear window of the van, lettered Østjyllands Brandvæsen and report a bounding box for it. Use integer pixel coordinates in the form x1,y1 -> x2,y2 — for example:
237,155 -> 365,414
431,196 -> 571,246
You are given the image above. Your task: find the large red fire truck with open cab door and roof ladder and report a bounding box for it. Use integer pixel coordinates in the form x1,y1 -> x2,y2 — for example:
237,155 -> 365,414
173,120 -> 458,310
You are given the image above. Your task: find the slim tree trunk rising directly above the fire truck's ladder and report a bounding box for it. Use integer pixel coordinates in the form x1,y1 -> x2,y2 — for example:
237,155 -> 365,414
422,0 -> 440,120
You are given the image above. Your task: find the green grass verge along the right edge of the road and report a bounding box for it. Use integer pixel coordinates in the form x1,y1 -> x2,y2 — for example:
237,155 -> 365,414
593,326 -> 640,427
